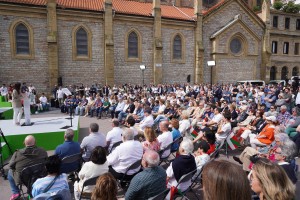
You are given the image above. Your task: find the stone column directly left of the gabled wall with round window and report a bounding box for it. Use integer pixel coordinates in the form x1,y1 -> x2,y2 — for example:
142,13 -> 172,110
194,0 -> 204,83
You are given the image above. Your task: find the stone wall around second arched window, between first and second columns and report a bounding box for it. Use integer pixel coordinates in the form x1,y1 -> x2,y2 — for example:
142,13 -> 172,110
57,19 -> 105,85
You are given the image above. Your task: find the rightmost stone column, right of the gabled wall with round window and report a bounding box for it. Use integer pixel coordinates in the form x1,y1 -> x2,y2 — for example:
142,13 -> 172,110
260,0 -> 271,82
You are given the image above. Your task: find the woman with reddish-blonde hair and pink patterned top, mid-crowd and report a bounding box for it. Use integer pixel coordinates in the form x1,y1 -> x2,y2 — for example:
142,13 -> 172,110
142,127 -> 160,152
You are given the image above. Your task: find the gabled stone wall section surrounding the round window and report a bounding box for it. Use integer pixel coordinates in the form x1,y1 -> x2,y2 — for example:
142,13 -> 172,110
203,1 -> 263,82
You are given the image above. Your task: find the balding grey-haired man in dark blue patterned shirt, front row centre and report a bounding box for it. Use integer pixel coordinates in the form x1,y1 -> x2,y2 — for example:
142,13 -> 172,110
125,150 -> 167,200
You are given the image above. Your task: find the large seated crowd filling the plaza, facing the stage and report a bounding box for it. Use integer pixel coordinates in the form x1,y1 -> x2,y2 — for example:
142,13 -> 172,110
4,83 -> 300,200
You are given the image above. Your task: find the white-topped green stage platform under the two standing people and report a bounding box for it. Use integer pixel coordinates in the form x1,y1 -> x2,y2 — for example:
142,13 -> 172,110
0,116 -> 79,159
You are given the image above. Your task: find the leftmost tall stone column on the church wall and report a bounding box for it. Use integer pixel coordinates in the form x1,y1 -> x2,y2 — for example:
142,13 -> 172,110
47,0 -> 59,94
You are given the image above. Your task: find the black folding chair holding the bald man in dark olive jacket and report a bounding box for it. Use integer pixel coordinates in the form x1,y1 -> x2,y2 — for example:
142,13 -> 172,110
19,163 -> 47,200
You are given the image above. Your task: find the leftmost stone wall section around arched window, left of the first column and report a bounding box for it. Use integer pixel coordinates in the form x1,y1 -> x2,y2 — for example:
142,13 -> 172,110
0,15 -> 49,92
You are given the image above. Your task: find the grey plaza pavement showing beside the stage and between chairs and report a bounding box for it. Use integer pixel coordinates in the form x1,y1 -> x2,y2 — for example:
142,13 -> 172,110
0,108 -> 300,200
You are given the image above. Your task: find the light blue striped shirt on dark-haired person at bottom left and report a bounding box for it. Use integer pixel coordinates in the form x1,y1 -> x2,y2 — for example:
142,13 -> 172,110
32,174 -> 69,197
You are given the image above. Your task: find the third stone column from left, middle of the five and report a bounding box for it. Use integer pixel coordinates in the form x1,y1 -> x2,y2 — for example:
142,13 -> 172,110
153,0 -> 162,84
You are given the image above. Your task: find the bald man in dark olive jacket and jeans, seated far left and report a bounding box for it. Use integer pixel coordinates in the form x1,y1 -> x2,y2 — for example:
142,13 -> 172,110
7,135 -> 48,199
